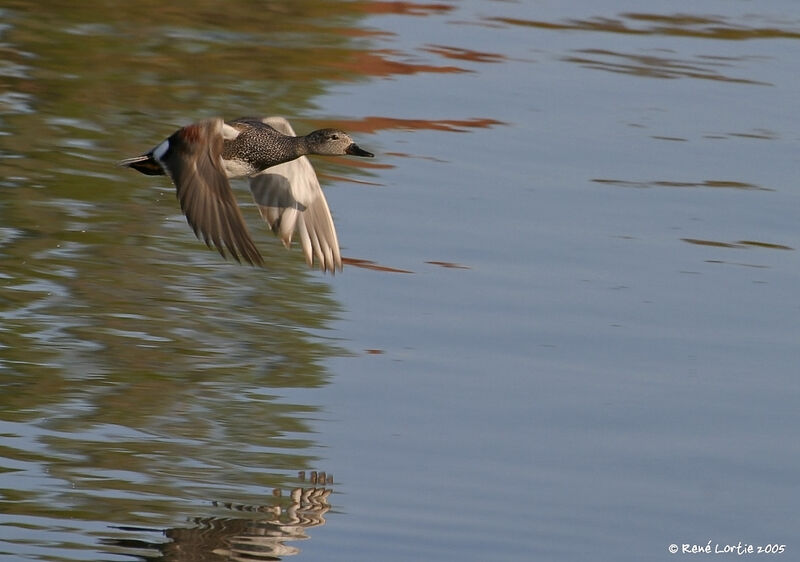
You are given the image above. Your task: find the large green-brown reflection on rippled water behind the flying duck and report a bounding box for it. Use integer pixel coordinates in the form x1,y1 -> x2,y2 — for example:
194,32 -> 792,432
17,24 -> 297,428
0,1 -> 364,552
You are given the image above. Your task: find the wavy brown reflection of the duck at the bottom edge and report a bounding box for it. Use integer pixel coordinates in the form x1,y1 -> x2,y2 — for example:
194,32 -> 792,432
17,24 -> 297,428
104,471 -> 333,562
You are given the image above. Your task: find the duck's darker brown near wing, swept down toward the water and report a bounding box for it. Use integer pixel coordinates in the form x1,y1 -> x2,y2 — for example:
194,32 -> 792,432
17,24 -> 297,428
161,119 -> 264,265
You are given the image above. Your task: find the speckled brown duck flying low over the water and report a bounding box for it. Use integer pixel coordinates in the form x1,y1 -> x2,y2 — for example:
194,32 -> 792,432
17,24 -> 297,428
120,117 -> 374,273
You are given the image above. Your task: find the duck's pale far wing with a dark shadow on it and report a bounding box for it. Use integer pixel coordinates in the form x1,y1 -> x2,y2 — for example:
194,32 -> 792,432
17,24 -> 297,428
250,117 -> 342,273
